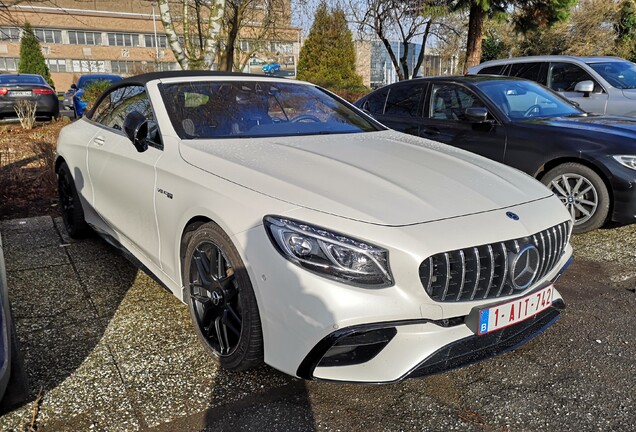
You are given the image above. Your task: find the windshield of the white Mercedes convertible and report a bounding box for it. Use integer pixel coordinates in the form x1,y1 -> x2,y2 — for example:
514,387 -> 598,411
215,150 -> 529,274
161,81 -> 379,139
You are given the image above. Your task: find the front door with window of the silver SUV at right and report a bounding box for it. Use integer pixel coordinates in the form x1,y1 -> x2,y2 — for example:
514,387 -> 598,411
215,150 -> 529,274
548,62 -> 609,114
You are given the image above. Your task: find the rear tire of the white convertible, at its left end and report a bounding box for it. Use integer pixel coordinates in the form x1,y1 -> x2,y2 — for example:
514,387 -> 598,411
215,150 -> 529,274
57,162 -> 91,239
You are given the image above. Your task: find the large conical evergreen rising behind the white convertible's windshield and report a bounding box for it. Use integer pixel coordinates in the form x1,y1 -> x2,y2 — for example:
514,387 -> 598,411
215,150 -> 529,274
298,1 -> 362,91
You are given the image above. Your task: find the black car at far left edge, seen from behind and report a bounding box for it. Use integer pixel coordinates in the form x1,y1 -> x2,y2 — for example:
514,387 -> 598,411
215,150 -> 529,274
0,74 -> 60,119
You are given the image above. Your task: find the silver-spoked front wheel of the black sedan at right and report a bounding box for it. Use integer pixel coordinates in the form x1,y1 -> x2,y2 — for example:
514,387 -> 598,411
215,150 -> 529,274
541,162 -> 610,233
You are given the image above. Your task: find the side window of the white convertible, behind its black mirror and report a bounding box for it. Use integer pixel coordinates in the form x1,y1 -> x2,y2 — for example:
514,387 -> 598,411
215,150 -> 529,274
92,85 -> 159,142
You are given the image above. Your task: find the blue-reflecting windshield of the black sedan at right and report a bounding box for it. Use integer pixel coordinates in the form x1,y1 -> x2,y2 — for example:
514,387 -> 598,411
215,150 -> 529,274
476,80 -> 586,119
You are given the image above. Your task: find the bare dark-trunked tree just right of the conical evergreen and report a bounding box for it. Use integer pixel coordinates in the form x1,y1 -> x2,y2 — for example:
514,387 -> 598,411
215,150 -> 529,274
349,0 -> 448,81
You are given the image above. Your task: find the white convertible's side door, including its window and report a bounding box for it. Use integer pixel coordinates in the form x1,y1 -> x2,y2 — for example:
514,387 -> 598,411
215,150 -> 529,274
88,85 -> 163,263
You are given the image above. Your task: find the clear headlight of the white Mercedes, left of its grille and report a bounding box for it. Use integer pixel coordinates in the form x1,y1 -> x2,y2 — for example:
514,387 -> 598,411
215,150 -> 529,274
263,216 -> 393,288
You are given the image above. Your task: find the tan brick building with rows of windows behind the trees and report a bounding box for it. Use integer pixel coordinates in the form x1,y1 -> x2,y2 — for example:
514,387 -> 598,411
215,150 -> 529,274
0,0 -> 300,91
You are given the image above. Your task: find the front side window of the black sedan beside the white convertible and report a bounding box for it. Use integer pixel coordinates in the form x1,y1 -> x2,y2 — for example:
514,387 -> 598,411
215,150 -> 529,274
429,84 -> 485,120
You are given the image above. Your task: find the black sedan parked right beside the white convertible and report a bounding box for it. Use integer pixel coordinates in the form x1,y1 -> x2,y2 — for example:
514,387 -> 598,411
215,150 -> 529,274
355,76 -> 636,233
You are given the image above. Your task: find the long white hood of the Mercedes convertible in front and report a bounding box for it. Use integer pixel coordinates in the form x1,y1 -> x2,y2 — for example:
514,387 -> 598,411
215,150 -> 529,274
180,131 -> 551,226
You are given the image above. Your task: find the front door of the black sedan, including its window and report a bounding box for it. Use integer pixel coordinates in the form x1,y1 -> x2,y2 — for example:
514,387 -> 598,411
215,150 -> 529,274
420,82 -> 506,162
